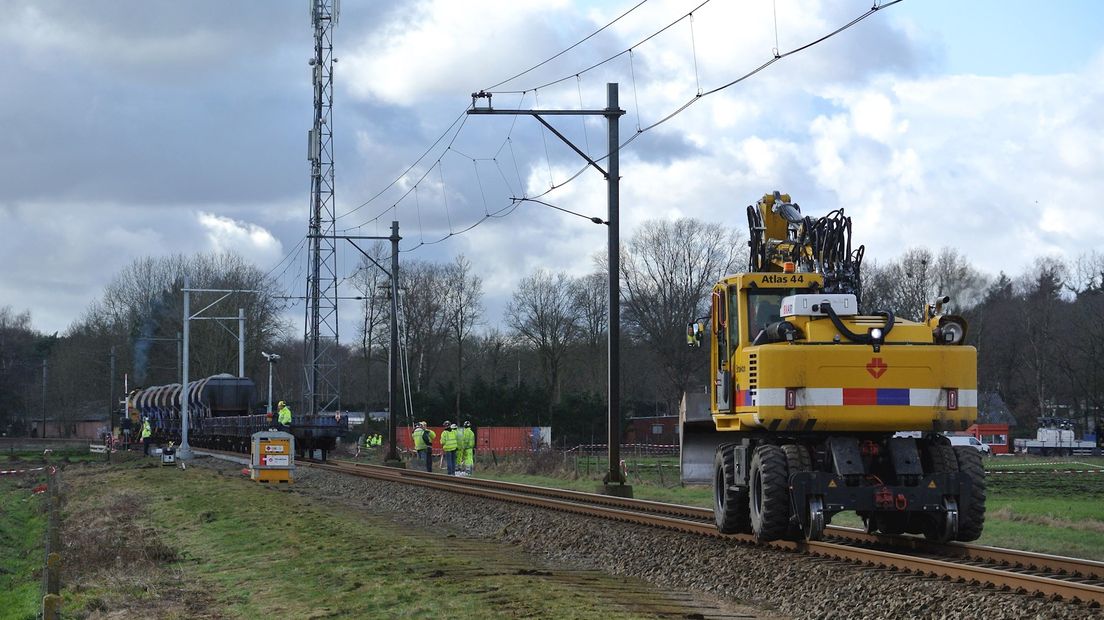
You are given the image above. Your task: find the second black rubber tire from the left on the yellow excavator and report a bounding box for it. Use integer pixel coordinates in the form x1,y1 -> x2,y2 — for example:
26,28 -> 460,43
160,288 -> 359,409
747,446 -> 789,543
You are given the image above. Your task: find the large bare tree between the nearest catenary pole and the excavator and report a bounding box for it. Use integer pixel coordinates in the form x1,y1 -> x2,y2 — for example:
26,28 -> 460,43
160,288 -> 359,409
620,218 -> 745,409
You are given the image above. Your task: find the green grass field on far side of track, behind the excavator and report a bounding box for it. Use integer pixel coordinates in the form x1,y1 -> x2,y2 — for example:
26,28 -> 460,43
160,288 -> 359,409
461,457 -> 1104,560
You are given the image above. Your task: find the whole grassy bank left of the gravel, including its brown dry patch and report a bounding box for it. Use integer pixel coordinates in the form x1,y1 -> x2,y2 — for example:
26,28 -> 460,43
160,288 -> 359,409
25,459 -> 724,620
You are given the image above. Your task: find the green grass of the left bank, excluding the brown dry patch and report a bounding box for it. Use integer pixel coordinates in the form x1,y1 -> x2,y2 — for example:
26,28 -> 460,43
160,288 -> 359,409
56,464 -> 697,619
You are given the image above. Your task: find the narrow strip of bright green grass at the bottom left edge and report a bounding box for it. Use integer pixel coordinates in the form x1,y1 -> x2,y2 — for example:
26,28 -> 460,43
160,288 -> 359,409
0,468 -> 46,619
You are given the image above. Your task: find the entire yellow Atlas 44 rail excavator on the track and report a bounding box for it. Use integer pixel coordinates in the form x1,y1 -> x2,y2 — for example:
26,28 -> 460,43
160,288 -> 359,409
681,192 -> 985,542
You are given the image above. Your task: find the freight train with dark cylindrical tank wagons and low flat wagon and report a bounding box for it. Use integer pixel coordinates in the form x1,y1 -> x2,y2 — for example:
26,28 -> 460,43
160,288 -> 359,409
126,374 -> 349,458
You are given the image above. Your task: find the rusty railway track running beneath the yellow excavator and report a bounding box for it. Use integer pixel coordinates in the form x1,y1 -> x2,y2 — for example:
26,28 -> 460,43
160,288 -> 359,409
304,454 -> 1104,608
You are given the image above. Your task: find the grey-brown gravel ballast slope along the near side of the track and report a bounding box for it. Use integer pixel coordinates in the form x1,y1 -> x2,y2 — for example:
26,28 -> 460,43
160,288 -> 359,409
198,459 -> 1104,620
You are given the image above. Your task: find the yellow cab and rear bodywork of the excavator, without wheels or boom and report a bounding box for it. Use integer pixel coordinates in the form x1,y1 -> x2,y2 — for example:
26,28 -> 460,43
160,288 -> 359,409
710,272 -> 977,432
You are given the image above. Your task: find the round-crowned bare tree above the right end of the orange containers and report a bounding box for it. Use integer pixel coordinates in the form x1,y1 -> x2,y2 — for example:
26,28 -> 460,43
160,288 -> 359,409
506,269 -> 580,405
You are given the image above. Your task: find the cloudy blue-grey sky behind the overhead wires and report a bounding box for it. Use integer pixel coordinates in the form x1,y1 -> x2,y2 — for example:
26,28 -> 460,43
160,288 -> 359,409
0,0 -> 1104,340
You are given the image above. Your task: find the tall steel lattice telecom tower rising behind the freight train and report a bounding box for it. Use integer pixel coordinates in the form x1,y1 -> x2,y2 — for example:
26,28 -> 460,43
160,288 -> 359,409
304,0 -> 340,414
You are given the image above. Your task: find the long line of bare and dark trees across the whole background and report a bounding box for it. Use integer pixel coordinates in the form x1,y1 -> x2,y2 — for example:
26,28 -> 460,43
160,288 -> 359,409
0,223 -> 1104,443
